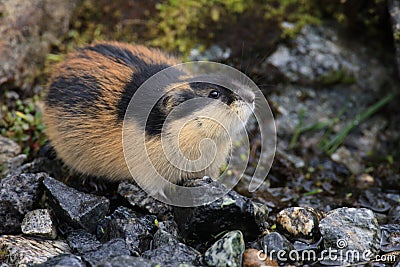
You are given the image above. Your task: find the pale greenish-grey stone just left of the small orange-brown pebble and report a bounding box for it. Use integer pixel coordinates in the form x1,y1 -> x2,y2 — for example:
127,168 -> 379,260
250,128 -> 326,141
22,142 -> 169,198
204,231 -> 244,267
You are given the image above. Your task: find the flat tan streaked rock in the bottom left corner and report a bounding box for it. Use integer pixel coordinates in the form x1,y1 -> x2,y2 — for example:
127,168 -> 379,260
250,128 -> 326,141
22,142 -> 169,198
0,235 -> 70,266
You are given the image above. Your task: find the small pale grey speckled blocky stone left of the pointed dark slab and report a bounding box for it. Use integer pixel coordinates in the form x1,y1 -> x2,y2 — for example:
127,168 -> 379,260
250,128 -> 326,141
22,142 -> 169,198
21,209 -> 57,239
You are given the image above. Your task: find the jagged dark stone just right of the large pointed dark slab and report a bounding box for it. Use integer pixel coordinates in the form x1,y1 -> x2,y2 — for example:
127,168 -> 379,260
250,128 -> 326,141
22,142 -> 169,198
97,207 -> 157,255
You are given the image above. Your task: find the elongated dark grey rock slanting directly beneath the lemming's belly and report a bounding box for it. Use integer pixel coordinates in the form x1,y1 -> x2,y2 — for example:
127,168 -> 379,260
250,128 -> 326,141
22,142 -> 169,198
118,182 -> 171,217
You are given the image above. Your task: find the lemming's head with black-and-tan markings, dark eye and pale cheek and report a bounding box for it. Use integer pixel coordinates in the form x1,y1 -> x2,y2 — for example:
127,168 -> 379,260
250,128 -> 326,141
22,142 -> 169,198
146,76 -> 255,138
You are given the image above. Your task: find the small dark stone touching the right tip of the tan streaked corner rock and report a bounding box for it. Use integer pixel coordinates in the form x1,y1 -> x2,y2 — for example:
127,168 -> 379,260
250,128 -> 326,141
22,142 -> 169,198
67,229 -> 101,255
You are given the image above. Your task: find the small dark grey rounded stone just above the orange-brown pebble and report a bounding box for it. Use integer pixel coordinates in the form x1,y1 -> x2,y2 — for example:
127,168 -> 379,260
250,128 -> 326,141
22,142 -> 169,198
261,232 -> 296,264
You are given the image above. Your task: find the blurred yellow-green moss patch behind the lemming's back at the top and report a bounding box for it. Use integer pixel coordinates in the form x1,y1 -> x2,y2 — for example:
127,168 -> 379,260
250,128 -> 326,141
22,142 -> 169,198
150,0 -> 320,55
